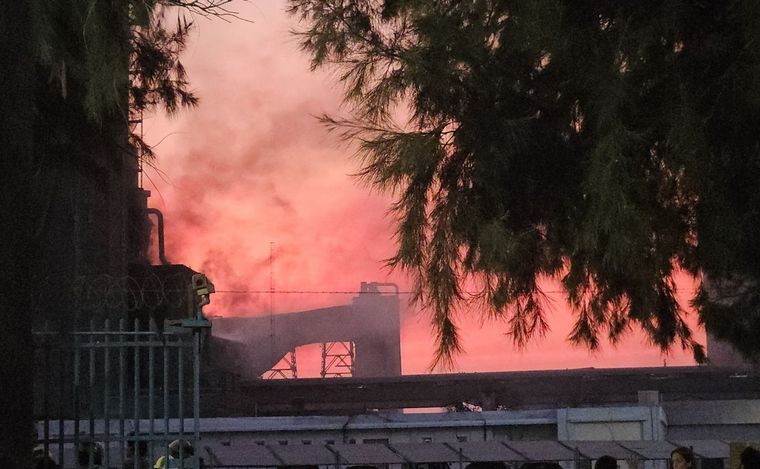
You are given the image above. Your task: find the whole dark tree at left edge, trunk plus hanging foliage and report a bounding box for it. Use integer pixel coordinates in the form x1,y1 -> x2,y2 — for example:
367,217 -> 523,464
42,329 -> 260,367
0,0 -> 242,469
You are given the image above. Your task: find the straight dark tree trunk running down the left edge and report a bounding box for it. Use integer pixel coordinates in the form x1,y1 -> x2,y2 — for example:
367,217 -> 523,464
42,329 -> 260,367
0,0 -> 35,469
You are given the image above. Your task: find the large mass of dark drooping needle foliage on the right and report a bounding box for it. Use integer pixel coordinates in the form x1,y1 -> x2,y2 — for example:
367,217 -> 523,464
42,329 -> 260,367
290,0 -> 760,365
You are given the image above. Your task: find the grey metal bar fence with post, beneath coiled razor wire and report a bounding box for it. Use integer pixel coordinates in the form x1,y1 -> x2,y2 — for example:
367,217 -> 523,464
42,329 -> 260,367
33,275 -> 213,469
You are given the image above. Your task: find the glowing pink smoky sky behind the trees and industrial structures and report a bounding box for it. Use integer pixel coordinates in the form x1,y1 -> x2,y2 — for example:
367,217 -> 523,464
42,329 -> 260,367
144,0 -> 704,376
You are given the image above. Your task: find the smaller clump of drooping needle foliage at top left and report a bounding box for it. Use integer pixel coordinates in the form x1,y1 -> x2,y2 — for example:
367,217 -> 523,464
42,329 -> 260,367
30,0 -> 242,159
